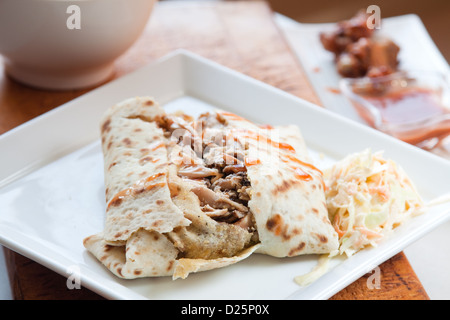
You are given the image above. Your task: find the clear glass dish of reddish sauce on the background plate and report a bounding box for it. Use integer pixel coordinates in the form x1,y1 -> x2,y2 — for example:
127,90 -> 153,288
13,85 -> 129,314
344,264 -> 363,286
340,71 -> 450,159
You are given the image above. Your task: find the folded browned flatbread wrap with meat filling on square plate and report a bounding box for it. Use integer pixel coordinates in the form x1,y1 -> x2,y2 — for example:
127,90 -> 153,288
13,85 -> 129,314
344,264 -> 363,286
84,97 -> 338,279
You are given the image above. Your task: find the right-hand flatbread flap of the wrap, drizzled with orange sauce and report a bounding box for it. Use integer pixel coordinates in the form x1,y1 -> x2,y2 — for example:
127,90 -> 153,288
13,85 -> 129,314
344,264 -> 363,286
217,113 -> 338,257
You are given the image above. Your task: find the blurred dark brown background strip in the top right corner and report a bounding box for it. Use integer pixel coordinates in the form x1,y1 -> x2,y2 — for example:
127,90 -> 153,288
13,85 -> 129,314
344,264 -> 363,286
169,0 -> 450,63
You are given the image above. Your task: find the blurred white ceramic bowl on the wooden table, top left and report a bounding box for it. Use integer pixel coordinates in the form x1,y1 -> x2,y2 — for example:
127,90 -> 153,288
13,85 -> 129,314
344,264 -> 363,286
0,0 -> 156,90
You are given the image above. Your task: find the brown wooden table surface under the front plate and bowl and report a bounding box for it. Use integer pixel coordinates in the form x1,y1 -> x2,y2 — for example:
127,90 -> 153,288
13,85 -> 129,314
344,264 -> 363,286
0,1 -> 428,299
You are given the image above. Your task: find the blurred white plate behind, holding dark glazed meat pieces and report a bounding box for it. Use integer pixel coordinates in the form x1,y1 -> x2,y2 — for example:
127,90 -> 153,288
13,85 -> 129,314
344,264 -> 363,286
275,14 -> 450,123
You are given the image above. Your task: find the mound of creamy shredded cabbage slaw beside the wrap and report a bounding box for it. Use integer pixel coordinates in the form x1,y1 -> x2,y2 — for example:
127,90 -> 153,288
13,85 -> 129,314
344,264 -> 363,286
324,149 -> 424,257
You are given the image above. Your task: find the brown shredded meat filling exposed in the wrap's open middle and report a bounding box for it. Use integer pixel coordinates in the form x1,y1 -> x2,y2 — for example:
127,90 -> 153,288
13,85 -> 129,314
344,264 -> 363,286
156,113 -> 256,232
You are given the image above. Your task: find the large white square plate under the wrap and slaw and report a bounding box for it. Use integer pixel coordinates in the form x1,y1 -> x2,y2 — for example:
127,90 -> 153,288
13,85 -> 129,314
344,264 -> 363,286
0,51 -> 450,299
